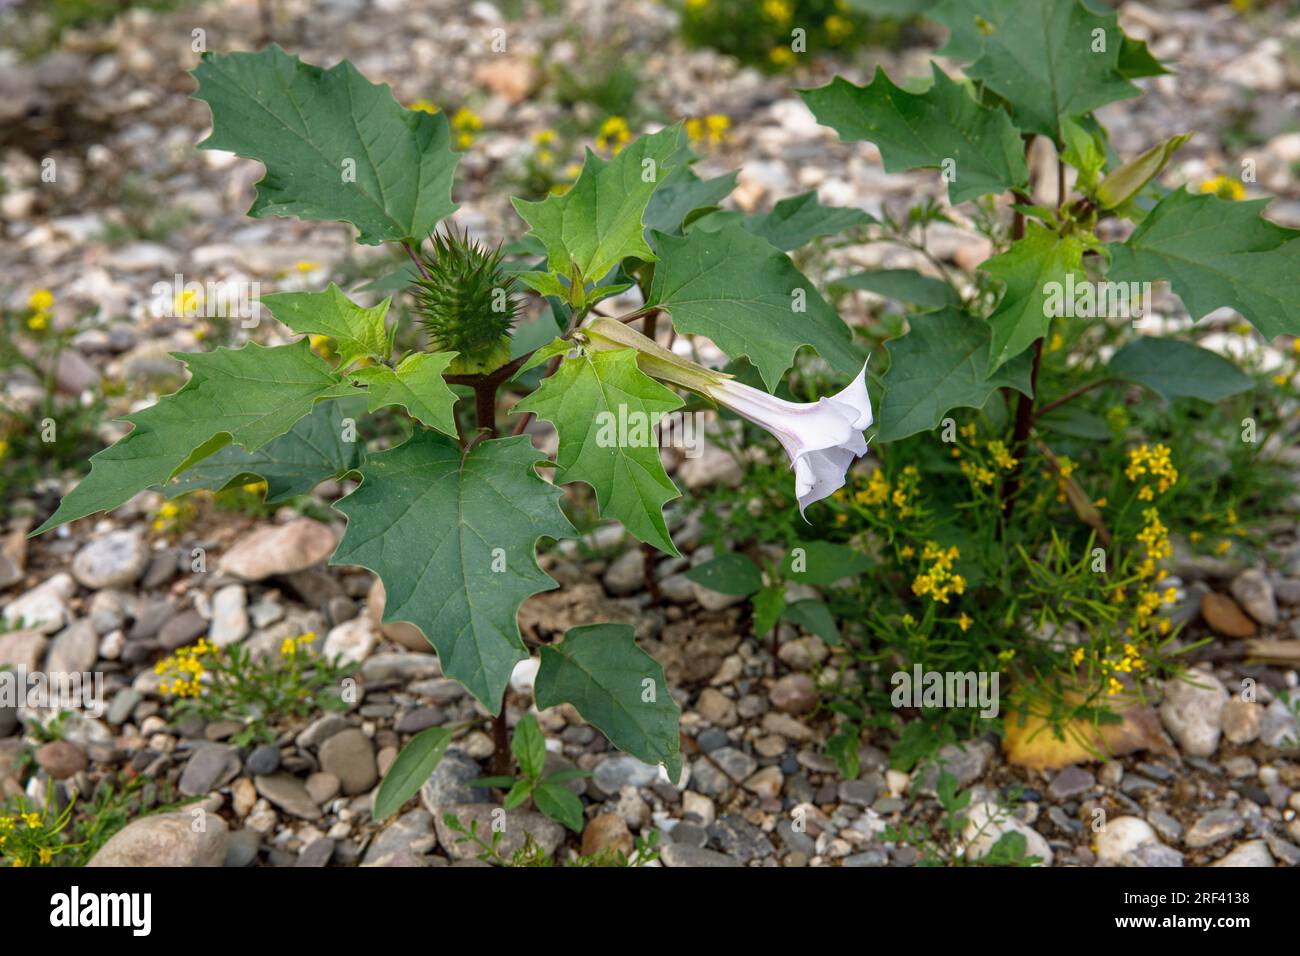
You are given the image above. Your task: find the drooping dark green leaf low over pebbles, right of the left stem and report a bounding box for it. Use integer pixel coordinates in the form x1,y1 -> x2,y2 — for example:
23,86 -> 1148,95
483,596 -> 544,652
533,624 -> 681,780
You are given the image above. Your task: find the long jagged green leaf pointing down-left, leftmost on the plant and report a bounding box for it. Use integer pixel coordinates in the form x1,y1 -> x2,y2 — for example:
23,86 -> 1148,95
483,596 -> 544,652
33,339 -> 352,535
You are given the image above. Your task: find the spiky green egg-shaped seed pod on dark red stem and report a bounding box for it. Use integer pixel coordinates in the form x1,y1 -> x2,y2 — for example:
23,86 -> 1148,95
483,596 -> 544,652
411,230 -> 519,375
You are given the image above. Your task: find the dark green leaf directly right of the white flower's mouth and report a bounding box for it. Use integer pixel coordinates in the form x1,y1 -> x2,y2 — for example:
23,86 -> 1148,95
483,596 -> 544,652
876,310 -> 1032,441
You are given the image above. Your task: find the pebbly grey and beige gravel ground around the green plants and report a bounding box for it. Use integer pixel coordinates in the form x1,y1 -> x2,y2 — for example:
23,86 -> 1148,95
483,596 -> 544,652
0,0 -> 1300,866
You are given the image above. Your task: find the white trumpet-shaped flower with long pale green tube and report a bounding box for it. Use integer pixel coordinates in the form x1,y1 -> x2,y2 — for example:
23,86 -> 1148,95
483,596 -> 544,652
584,319 -> 874,514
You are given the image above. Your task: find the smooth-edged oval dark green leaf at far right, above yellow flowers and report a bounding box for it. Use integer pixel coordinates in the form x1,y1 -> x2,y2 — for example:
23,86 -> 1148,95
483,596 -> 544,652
1108,336 -> 1255,402
